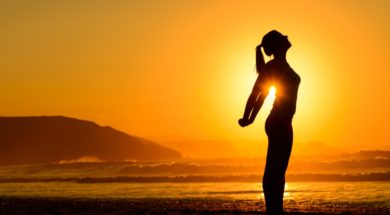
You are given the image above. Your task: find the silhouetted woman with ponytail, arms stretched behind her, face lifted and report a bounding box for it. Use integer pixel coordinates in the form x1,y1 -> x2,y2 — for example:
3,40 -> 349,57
238,30 -> 301,215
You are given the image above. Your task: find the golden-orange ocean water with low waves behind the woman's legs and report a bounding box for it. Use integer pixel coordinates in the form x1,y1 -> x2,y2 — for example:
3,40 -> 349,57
0,163 -> 390,214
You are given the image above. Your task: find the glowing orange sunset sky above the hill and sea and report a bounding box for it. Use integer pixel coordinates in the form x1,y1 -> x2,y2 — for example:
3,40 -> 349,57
0,0 -> 390,155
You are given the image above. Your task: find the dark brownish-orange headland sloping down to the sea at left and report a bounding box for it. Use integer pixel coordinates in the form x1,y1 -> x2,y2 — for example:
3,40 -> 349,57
0,116 -> 181,164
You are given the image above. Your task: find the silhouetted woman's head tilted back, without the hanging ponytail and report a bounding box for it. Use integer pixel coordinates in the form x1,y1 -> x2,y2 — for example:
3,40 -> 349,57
261,30 -> 291,56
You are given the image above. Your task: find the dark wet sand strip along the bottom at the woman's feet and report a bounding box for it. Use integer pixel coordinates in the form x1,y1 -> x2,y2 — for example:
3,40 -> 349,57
0,197 -> 390,215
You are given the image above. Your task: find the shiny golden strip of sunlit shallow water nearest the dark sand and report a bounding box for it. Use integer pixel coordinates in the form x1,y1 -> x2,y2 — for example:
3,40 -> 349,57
0,182 -> 390,206
